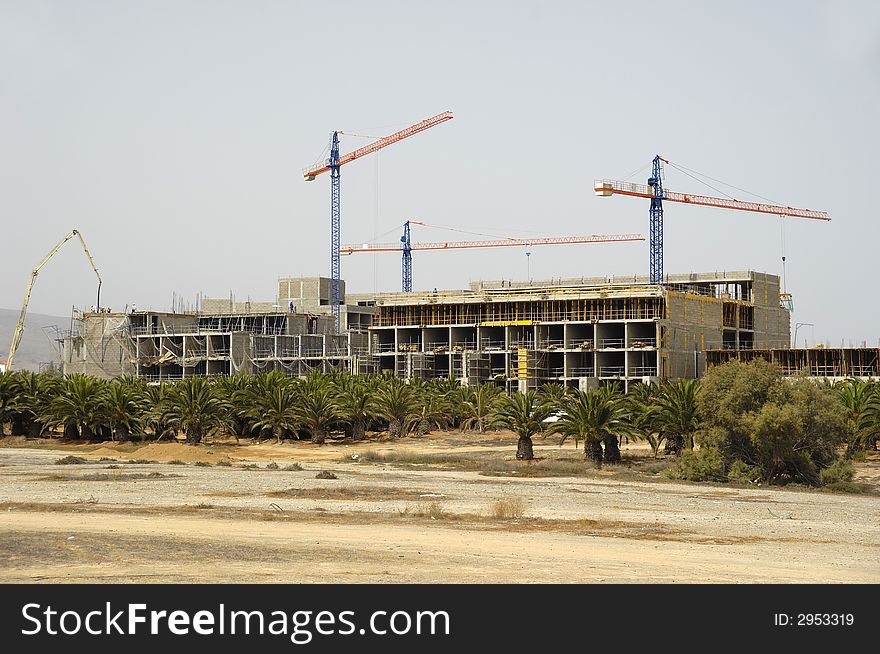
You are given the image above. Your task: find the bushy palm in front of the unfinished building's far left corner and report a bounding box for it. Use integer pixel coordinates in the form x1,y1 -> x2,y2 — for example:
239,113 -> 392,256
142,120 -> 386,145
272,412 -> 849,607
40,374 -> 107,438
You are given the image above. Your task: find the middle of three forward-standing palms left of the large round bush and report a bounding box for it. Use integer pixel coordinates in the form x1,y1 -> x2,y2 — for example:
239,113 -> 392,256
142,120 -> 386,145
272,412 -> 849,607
549,385 -> 629,465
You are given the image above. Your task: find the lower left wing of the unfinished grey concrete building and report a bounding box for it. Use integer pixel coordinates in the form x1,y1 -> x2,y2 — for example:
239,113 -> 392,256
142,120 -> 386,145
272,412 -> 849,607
62,278 -> 373,382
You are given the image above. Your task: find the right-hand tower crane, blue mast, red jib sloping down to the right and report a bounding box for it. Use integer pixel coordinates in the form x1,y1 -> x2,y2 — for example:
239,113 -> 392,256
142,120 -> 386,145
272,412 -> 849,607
593,154 -> 831,285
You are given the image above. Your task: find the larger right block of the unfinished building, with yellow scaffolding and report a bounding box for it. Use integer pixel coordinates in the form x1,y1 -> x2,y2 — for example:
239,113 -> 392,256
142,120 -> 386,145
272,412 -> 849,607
360,271 -> 789,390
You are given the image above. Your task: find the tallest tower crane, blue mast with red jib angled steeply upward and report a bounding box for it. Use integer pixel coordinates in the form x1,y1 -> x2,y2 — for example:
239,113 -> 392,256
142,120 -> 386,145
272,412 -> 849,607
303,111 -> 452,333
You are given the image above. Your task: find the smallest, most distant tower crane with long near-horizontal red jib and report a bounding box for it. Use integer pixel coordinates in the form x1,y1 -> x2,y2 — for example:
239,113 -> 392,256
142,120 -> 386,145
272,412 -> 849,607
341,220 -> 645,293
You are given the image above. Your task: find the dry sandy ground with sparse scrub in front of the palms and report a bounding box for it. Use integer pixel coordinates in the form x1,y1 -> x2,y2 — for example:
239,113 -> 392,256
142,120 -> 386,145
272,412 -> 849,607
0,434 -> 880,583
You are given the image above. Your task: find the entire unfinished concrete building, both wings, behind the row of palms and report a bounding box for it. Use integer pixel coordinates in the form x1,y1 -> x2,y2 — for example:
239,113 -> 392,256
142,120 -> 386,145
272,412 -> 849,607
62,271 -> 790,389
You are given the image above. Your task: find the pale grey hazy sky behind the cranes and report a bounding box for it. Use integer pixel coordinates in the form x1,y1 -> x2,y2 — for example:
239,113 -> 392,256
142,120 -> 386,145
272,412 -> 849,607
0,0 -> 880,345
